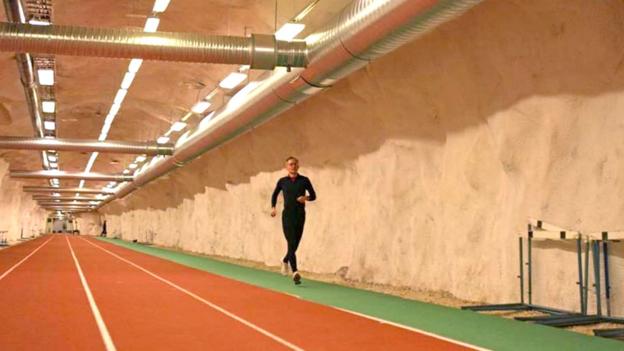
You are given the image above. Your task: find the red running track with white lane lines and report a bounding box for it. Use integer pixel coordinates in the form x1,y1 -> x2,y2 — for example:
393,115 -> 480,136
0,235 -> 478,351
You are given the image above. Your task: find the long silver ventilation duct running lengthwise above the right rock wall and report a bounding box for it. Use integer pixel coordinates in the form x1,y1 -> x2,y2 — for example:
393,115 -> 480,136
101,0 -> 481,206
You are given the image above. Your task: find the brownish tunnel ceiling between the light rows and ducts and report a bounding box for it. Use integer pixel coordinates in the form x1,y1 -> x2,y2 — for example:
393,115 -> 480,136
0,0 -> 350,198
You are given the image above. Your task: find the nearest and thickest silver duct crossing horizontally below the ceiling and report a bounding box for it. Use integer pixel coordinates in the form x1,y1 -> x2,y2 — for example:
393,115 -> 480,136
0,23 -> 307,69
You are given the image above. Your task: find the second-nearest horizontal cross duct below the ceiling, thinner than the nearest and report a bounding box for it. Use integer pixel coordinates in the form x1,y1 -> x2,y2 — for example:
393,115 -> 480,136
0,136 -> 173,155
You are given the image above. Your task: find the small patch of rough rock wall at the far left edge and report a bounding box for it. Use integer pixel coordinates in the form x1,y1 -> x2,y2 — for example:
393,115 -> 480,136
0,159 -> 47,242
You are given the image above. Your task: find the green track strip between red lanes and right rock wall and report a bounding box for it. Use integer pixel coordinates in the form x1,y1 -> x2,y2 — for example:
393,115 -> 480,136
99,238 -> 624,351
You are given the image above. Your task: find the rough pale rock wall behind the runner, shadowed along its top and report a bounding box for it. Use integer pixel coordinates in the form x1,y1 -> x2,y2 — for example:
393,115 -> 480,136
105,0 -> 624,314
